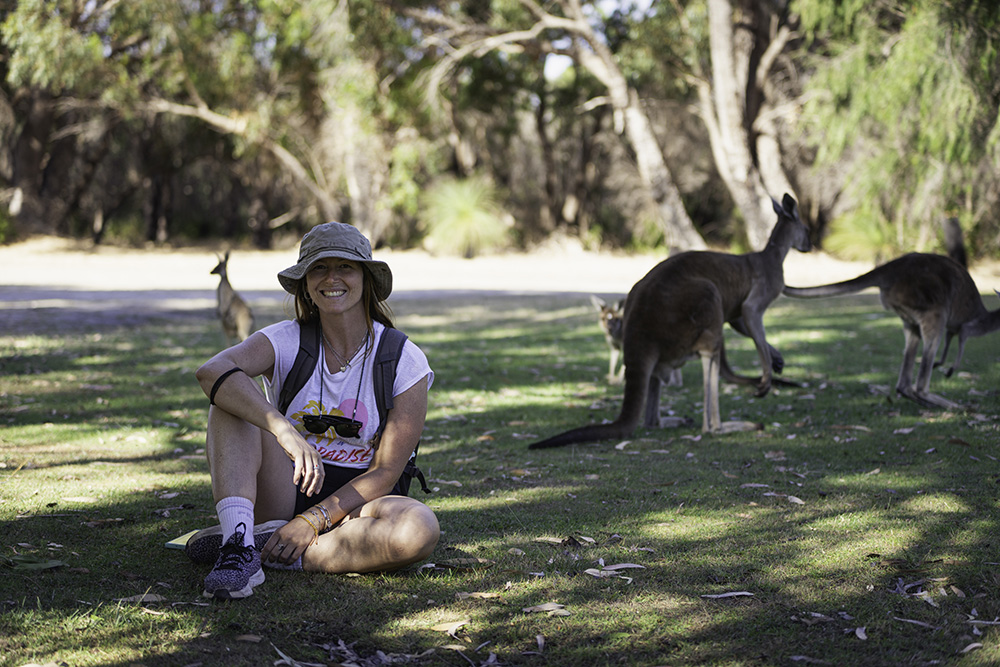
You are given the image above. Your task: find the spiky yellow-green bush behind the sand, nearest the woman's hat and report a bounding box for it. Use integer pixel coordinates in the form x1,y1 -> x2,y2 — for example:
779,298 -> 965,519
420,176 -> 511,258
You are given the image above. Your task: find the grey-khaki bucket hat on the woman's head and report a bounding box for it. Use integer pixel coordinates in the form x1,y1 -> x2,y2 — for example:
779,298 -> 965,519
278,222 -> 392,301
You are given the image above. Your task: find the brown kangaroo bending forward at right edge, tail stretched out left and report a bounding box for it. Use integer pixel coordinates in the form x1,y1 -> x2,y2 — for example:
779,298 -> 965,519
784,253 -> 1000,410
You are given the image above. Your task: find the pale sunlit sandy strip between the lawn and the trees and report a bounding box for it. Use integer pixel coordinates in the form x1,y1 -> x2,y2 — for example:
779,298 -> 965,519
0,237 -> 1000,331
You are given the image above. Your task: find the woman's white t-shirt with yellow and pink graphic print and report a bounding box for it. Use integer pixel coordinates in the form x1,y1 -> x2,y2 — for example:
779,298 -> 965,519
261,320 -> 434,468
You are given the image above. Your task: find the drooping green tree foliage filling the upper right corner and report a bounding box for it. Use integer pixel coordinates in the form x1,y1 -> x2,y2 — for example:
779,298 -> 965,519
794,0 -> 1000,258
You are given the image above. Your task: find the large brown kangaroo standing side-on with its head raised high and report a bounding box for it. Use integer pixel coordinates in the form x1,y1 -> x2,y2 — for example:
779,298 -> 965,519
528,194 -> 812,449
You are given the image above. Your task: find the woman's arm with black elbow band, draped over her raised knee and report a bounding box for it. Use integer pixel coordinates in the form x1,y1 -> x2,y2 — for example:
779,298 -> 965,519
195,331 -> 324,495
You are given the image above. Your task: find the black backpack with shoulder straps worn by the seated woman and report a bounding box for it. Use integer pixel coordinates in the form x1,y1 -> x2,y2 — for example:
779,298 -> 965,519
278,319 -> 431,496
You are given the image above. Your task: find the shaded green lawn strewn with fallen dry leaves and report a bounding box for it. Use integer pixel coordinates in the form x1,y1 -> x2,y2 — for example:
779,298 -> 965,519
0,294 -> 1000,667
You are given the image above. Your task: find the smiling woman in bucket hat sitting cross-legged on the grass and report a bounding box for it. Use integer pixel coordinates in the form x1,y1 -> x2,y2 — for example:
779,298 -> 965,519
185,222 -> 440,598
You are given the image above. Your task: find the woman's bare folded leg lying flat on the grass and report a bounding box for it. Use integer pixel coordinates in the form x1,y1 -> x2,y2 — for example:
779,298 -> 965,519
302,496 -> 441,573
